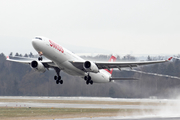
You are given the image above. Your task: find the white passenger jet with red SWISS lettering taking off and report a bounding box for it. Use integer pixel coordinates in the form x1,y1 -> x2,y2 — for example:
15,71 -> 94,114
7,36 -> 172,85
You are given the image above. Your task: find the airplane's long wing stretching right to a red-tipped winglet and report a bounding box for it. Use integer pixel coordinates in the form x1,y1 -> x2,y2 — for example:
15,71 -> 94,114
71,57 -> 172,71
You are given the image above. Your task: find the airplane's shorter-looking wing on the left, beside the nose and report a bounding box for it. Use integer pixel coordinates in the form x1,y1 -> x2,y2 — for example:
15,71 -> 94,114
6,56 -> 58,68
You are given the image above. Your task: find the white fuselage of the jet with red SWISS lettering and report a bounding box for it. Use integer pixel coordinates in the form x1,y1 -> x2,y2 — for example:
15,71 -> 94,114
32,37 -> 111,83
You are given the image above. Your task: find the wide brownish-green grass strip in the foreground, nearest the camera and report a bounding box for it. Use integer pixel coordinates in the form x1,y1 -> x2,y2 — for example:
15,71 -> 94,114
0,108 -> 155,120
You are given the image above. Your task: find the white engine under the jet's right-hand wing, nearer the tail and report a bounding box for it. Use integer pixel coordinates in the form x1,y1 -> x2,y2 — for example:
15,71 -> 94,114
83,61 -> 99,73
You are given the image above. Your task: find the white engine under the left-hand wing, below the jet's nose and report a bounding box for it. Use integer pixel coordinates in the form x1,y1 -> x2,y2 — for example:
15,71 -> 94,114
30,60 -> 46,73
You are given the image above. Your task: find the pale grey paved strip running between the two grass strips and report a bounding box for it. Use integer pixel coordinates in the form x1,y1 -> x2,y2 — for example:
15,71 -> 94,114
0,102 -> 165,109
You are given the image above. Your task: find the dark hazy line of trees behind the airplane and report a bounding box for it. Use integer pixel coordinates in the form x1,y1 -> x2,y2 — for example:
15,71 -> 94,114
0,53 -> 180,98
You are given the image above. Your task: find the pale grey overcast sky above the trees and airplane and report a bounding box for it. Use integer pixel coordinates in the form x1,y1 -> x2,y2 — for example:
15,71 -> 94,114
0,0 -> 180,55
